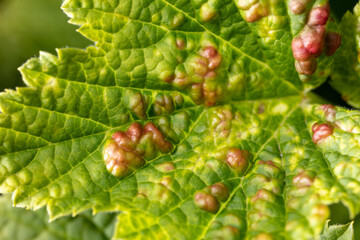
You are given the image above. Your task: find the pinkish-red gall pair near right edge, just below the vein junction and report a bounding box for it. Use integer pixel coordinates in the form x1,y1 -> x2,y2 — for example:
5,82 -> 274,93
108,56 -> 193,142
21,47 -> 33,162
311,105 -> 336,144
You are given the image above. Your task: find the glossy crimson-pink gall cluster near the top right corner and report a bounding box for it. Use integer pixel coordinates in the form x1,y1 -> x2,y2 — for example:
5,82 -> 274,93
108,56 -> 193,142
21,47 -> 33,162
290,0 -> 341,75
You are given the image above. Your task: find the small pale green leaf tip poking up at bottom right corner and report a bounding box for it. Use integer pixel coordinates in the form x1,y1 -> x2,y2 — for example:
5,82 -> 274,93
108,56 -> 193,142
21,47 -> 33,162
321,222 -> 354,240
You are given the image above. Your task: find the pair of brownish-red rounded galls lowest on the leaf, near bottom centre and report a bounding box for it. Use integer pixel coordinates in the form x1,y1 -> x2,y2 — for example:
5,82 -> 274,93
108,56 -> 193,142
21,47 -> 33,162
194,183 -> 230,213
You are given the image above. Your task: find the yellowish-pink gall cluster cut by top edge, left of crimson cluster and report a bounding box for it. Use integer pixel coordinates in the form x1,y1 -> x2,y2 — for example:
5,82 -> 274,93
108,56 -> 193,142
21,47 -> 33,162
235,0 -> 270,23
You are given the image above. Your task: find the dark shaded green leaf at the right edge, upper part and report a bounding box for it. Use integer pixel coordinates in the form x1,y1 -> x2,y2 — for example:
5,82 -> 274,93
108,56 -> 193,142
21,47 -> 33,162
330,4 -> 360,108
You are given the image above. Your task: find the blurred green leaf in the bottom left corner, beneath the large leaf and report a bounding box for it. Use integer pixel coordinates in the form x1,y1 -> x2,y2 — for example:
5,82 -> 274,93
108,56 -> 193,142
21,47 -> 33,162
0,196 -> 116,240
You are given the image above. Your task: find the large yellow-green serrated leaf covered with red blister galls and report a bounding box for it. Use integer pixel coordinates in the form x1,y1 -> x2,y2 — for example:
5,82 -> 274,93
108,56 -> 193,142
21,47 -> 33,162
0,0 -> 360,239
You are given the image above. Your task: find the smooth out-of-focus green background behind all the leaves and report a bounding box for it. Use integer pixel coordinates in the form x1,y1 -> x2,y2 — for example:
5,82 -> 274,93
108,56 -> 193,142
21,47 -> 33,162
0,0 -> 360,240
